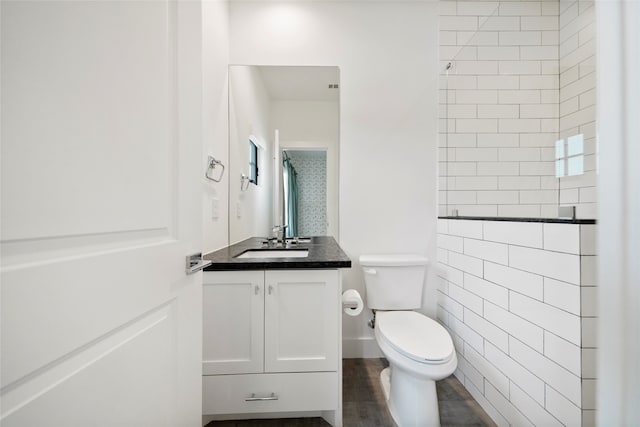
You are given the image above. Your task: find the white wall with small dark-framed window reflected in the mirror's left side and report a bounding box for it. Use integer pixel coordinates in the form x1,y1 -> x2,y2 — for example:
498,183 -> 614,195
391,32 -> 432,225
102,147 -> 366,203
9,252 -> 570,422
229,66 -> 274,244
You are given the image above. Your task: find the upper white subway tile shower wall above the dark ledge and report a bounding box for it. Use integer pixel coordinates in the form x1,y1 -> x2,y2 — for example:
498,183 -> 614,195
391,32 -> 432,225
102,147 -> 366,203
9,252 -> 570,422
439,0 -> 597,218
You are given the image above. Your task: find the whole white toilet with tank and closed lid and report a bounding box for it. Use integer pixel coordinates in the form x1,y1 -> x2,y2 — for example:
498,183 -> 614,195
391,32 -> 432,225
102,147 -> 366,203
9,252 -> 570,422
360,254 -> 458,427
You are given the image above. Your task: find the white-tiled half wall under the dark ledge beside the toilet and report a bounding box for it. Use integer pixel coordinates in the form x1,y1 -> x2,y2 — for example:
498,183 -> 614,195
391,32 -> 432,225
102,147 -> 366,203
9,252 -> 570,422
437,219 -> 597,426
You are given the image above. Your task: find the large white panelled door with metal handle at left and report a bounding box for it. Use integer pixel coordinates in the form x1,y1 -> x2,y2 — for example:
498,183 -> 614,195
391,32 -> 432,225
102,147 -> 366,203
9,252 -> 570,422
0,0 -> 202,427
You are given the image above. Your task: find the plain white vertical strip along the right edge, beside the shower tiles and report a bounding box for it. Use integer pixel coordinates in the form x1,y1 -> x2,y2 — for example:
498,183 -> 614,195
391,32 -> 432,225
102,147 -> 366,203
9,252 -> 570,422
595,1 -> 640,426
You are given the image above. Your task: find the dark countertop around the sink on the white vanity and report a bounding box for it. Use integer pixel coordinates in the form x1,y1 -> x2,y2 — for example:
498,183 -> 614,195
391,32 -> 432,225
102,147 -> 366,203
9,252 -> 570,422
202,236 -> 351,271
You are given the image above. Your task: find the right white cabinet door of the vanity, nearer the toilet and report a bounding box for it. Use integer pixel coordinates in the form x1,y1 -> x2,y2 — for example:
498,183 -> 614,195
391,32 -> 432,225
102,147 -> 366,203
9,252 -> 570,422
265,270 -> 341,372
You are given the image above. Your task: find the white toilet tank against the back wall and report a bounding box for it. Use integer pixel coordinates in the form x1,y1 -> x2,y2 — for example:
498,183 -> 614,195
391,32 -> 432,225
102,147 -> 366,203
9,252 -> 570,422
360,254 -> 429,310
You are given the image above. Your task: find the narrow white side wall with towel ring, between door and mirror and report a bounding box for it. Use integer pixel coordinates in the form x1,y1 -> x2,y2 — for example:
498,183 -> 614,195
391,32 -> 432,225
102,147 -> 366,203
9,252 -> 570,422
201,1 -> 229,253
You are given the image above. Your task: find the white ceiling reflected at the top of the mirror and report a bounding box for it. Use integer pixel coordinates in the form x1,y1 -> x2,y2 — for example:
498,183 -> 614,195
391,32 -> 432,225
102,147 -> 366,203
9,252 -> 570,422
258,66 -> 340,101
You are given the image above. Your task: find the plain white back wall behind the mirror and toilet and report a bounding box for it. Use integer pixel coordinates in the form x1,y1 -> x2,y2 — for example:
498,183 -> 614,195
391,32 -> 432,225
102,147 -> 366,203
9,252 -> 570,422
229,2 -> 438,356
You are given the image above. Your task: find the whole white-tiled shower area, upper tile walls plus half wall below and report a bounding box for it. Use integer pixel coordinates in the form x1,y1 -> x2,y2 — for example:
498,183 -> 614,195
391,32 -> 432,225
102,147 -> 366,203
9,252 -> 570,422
437,0 -> 598,426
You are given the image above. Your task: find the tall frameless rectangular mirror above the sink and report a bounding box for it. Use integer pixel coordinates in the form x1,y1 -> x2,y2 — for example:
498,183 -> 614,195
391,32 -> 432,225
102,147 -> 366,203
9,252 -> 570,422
229,65 -> 340,244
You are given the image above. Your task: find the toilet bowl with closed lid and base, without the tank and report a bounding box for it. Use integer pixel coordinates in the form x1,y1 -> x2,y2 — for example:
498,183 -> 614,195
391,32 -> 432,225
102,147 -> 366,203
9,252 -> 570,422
375,311 -> 458,427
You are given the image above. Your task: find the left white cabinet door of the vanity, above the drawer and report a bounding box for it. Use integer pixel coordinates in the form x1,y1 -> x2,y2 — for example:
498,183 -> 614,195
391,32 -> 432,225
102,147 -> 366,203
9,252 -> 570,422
202,271 -> 264,375
